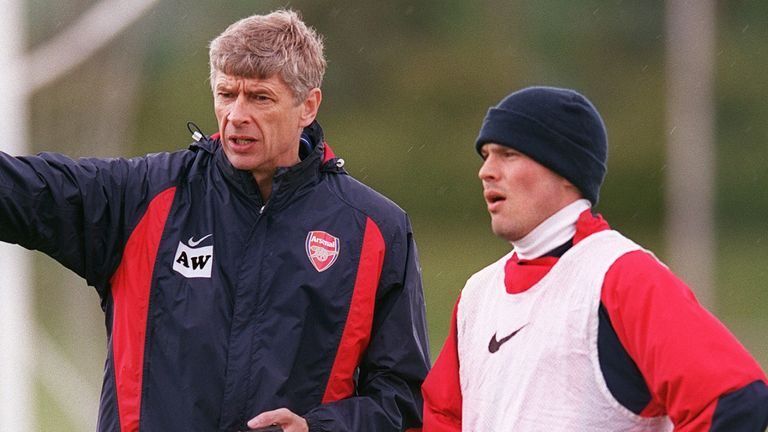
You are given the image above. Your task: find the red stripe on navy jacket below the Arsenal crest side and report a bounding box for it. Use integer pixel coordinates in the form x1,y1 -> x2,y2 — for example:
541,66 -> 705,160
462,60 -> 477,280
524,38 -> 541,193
323,218 -> 386,403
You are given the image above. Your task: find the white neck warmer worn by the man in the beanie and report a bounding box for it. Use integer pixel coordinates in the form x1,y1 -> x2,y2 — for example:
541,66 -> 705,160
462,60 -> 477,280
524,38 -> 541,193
512,199 -> 591,260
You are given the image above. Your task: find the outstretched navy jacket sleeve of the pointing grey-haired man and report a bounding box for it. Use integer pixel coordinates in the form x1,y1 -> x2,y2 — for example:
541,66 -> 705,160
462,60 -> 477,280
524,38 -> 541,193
0,153 -> 175,294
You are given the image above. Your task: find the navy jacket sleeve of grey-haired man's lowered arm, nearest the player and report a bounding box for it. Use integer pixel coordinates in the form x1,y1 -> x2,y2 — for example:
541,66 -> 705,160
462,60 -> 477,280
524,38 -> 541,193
304,221 -> 430,432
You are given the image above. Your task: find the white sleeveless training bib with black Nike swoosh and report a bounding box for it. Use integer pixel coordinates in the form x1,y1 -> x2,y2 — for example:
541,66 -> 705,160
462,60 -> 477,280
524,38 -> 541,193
457,231 -> 672,432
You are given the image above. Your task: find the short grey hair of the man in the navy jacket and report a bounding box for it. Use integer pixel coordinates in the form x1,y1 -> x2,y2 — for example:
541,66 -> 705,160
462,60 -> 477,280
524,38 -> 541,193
209,9 -> 326,103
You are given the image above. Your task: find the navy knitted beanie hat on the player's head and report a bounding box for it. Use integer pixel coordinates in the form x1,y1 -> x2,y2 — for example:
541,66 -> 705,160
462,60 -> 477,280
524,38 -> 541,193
475,87 -> 608,206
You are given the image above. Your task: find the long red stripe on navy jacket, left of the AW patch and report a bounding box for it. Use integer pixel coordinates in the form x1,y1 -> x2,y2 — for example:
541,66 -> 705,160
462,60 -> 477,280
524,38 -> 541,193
111,188 -> 176,432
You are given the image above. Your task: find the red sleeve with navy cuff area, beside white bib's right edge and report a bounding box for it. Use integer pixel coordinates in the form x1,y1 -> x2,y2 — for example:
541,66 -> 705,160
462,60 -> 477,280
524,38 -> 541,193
601,251 -> 768,432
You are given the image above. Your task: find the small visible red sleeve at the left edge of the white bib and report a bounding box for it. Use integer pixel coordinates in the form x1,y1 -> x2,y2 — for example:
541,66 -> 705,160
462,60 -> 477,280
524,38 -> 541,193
422,298 -> 462,432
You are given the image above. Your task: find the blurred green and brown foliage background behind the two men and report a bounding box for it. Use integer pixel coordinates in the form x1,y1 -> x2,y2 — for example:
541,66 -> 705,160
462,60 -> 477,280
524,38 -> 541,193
22,0 -> 768,428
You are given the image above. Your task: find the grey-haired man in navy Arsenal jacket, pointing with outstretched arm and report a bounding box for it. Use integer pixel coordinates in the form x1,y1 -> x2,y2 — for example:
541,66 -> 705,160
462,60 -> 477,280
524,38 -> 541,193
0,10 -> 430,432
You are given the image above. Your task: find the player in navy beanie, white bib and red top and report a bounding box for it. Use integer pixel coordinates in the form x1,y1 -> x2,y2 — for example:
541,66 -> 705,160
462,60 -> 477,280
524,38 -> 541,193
423,87 -> 768,432
